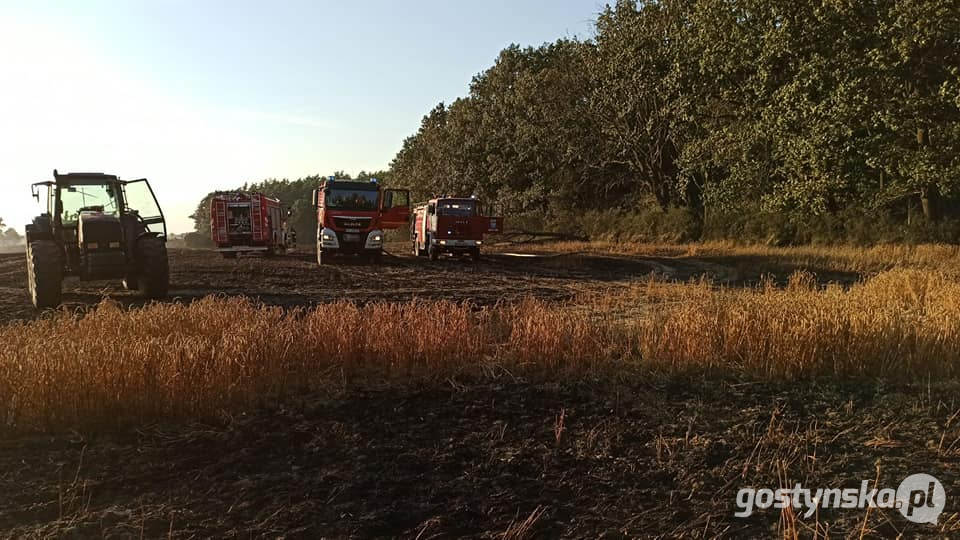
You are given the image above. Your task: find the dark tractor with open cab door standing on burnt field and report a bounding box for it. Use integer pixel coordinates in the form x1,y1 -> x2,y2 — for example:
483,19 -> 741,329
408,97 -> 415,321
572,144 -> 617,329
26,170 -> 170,309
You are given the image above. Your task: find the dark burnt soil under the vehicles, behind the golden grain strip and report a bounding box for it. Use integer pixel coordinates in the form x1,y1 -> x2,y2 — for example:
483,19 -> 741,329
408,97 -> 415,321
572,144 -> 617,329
0,244 -> 859,323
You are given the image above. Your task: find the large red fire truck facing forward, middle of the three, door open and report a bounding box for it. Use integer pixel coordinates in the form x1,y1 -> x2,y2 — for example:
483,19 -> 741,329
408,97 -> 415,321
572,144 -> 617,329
313,176 -> 410,265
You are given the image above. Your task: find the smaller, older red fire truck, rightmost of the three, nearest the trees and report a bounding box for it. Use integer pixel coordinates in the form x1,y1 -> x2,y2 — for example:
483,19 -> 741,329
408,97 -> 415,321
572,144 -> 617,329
410,197 -> 503,261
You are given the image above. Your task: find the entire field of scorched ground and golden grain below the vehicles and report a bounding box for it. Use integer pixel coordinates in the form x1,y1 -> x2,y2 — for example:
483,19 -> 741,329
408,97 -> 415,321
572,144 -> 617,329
0,243 -> 960,538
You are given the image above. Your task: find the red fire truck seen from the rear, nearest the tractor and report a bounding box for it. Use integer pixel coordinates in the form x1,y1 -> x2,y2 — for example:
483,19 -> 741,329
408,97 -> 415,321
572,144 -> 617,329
210,191 -> 295,259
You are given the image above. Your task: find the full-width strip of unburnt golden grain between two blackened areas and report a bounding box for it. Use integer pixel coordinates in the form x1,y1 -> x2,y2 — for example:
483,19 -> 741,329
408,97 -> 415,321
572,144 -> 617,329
0,262 -> 960,431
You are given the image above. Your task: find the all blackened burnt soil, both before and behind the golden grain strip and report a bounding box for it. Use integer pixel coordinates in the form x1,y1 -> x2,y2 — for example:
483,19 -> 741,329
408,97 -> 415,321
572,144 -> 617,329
0,249 -> 960,539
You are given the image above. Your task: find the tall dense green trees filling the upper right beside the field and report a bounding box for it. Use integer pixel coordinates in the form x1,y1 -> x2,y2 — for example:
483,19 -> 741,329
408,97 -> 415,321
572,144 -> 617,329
391,0 -> 960,242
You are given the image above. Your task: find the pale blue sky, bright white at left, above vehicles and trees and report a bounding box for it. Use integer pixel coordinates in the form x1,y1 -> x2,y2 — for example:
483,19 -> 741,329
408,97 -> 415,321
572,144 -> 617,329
0,0 -> 603,232
